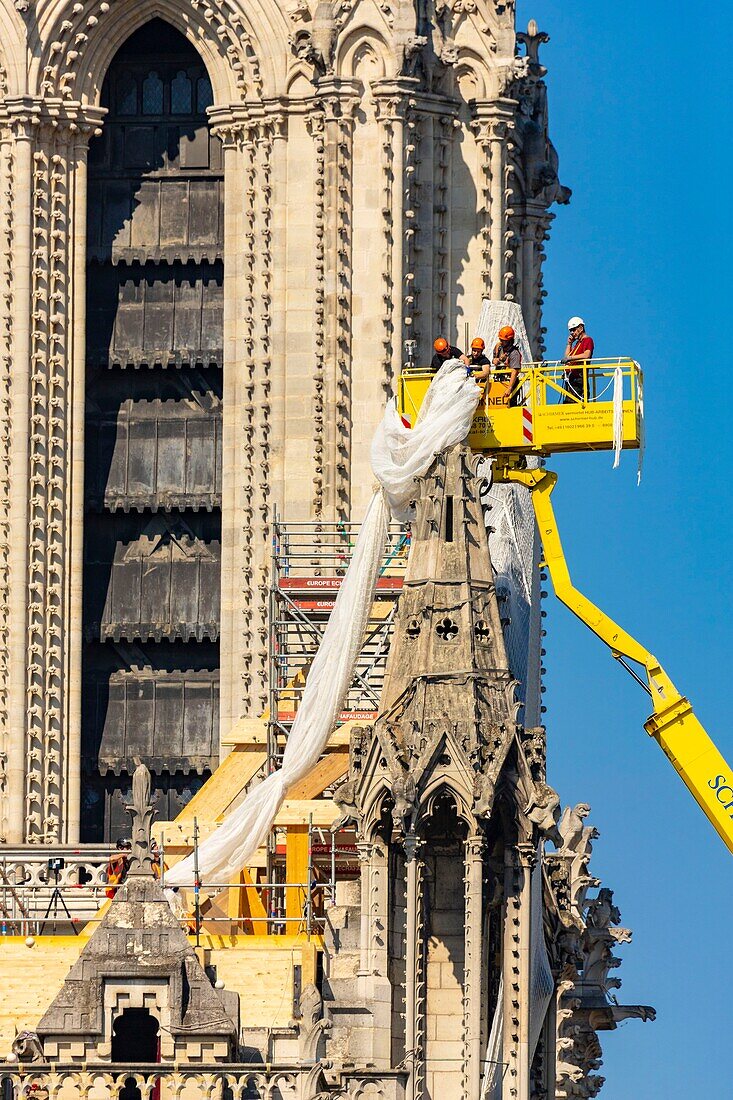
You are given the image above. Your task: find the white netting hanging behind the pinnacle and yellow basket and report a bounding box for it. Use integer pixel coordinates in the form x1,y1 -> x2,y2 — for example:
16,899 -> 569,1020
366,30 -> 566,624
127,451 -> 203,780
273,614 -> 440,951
477,300 -> 540,727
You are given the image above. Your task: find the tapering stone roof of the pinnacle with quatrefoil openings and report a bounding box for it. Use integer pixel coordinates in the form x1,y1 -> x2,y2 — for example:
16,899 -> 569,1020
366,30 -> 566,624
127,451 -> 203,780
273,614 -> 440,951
354,447 -> 530,825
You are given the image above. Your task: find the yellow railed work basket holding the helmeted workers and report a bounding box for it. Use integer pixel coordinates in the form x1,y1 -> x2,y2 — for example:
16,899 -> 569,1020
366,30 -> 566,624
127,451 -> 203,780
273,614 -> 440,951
397,359 -> 643,454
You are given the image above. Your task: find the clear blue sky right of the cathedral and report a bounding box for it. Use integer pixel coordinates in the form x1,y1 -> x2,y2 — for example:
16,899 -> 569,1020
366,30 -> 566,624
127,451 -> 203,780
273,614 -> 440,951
517,0 -> 733,1100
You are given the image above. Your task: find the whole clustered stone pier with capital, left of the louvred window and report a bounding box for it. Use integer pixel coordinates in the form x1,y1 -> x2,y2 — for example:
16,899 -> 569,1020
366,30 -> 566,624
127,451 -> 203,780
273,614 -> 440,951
3,101 -> 103,843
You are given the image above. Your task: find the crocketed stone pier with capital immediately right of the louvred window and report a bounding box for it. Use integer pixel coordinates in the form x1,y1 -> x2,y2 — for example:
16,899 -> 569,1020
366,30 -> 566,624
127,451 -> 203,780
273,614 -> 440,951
210,107 -> 277,721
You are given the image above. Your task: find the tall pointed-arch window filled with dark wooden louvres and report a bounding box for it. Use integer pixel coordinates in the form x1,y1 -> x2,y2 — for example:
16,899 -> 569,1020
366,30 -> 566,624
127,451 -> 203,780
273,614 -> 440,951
81,20 -> 223,839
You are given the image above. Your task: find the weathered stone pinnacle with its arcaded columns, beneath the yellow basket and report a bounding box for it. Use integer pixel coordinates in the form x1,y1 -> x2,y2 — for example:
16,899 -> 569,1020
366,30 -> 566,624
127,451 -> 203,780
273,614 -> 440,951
326,447 -> 559,1100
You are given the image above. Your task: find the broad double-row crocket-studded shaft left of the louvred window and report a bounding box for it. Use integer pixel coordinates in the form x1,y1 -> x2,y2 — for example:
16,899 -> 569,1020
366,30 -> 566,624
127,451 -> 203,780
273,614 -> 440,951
25,117 -> 76,843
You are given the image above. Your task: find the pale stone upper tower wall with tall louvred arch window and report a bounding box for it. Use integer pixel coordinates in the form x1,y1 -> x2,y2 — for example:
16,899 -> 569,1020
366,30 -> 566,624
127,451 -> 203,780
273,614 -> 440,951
0,0 -> 568,844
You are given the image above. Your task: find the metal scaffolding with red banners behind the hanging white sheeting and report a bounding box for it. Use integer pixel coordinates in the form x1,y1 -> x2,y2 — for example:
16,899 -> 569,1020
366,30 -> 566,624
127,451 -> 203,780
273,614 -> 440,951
267,513 -> 409,768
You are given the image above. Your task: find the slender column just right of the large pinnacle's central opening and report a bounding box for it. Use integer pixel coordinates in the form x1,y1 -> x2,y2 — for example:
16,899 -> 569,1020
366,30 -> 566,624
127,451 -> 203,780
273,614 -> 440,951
463,835 -> 485,1100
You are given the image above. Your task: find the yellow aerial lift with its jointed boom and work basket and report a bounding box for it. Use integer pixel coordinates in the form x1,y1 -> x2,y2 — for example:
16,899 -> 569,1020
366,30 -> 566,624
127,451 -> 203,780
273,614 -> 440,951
397,360 -> 733,851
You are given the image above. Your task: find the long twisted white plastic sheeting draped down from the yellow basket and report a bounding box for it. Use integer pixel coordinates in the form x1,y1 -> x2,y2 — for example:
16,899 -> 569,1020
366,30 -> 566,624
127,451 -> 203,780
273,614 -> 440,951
166,360 -> 479,887
